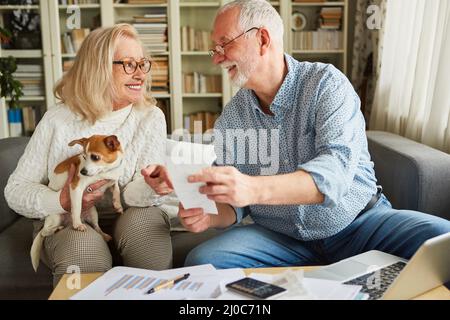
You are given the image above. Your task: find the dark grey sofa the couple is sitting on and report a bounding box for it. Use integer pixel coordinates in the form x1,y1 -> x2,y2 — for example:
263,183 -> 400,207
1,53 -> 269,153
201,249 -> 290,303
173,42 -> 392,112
0,131 -> 450,299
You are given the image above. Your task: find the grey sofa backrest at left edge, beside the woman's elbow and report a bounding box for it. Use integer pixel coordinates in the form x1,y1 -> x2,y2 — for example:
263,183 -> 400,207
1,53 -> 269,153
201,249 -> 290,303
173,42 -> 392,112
0,137 -> 29,232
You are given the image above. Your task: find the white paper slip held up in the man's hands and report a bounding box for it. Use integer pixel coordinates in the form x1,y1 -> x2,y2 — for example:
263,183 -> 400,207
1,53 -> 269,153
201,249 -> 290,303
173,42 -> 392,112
166,157 -> 218,214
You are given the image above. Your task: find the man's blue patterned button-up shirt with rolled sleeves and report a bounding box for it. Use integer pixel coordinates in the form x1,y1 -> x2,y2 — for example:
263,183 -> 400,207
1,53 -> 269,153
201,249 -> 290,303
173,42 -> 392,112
214,54 -> 376,241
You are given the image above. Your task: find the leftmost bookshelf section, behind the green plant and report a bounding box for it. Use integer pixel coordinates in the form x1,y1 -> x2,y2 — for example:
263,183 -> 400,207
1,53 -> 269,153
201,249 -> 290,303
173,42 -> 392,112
0,1 -> 53,138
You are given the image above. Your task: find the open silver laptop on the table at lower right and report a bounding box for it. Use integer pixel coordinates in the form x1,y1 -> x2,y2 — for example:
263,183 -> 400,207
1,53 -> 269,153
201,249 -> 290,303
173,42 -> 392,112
305,232 -> 450,300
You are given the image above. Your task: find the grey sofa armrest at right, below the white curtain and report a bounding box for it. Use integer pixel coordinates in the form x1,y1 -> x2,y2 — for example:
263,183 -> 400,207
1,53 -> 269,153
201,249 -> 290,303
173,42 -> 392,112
367,131 -> 450,219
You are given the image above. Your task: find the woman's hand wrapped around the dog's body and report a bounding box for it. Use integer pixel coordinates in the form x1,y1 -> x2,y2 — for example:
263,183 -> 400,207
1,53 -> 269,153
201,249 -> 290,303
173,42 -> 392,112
59,164 -> 109,212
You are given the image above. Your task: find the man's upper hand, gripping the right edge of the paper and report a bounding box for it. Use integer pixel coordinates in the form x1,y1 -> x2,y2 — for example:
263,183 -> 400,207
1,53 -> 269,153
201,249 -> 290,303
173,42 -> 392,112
188,167 -> 257,207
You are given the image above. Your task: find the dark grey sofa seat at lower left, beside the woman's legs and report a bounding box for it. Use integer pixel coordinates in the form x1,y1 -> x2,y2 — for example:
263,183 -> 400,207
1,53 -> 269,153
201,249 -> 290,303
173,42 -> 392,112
0,217 -> 53,299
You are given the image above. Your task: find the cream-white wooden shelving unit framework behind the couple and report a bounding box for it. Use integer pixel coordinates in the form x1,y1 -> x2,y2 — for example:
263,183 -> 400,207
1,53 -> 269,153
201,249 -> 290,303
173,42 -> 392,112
0,0 -> 348,138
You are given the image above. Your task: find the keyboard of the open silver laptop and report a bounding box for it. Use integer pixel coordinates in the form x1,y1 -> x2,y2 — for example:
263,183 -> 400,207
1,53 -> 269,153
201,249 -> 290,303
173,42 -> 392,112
344,261 -> 406,300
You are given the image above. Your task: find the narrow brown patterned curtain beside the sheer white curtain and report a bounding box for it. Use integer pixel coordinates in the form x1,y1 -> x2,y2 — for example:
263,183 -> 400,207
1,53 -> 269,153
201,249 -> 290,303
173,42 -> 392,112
351,0 -> 386,123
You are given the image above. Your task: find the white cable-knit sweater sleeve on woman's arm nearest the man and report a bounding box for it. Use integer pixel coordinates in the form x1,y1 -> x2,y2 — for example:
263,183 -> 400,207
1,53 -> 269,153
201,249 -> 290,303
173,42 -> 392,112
123,107 -> 167,207
